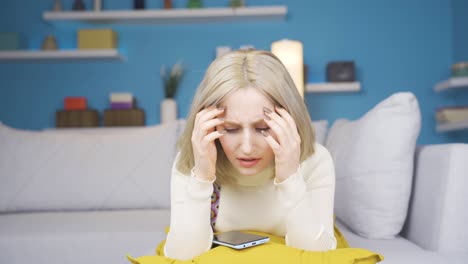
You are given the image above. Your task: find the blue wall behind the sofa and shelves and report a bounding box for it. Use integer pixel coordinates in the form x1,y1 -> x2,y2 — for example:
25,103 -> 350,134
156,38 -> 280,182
0,0 -> 468,144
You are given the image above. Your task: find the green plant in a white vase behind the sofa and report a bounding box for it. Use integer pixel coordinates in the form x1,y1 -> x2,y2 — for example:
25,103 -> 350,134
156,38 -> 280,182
160,62 -> 184,124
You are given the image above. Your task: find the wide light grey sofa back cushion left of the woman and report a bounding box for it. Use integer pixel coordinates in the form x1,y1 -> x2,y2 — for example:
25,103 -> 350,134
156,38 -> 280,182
0,121 -> 182,212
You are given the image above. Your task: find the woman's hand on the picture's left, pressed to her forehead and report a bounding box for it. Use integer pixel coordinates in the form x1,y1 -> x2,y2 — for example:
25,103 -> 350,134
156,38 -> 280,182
192,106 -> 226,181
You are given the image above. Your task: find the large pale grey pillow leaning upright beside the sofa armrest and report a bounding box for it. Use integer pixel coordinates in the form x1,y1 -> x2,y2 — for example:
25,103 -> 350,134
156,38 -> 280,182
326,93 -> 421,238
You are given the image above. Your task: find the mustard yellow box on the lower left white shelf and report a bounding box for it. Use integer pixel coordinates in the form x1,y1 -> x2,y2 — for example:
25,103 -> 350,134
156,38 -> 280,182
78,29 -> 118,49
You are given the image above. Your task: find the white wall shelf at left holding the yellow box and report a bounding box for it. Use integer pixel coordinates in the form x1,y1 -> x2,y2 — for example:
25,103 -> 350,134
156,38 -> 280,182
0,49 -> 123,61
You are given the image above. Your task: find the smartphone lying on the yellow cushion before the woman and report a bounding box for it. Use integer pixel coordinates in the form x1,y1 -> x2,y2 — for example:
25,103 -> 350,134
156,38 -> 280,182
213,231 -> 270,249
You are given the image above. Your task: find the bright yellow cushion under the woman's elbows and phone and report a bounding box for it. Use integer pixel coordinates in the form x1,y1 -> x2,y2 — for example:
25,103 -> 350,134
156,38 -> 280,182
127,226 -> 383,264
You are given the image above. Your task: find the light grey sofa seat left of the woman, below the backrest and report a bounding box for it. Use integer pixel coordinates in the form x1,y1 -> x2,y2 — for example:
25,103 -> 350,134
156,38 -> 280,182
0,209 -> 170,264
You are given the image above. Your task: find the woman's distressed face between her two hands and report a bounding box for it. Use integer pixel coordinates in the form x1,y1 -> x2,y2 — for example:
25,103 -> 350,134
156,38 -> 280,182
216,88 -> 276,176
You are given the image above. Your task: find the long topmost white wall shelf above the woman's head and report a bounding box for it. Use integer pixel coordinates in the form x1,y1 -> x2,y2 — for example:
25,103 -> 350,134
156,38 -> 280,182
43,6 -> 288,24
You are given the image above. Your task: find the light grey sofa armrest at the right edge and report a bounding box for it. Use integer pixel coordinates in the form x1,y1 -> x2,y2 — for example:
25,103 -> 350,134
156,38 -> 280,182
402,144 -> 468,252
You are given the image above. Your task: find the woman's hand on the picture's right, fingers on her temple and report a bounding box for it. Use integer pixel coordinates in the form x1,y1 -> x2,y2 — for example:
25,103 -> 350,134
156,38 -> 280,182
262,106 -> 301,183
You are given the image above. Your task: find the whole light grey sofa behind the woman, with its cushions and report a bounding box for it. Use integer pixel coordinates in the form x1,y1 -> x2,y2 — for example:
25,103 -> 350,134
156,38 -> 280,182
0,94 -> 468,264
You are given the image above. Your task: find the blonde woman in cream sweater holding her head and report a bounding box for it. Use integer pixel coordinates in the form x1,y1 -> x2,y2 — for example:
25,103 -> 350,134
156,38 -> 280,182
164,50 -> 336,260
